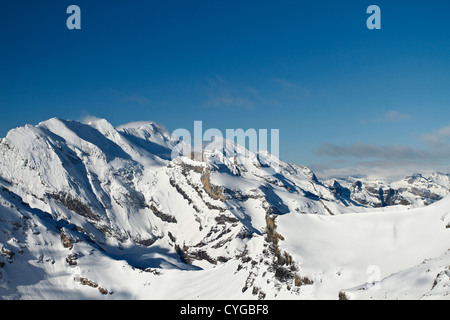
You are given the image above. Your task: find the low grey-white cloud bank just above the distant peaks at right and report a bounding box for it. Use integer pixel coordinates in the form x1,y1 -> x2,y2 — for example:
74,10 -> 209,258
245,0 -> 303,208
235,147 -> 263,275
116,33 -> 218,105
313,125 -> 450,178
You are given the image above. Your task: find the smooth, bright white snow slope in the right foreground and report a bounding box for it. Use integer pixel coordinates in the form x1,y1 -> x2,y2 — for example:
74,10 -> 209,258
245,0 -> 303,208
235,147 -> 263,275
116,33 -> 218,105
277,197 -> 450,299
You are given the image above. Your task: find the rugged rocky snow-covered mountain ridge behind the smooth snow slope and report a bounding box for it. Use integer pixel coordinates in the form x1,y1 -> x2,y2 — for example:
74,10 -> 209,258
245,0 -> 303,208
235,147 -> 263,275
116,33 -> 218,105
0,118 -> 449,299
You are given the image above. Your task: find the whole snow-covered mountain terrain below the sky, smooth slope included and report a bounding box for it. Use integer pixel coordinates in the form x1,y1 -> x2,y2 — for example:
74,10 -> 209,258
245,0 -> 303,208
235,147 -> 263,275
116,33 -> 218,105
0,119 -> 450,299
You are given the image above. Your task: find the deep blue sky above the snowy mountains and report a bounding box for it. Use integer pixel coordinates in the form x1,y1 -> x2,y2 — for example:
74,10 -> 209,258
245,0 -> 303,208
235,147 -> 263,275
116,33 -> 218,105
0,0 -> 450,178
